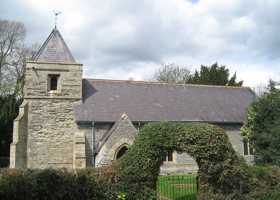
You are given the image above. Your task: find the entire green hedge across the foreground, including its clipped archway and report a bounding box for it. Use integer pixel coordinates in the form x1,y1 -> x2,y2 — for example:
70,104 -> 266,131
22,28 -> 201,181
0,122 -> 280,200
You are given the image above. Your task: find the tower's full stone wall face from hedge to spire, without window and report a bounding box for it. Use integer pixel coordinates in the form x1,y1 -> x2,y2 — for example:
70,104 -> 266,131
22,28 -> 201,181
24,62 -> 82,168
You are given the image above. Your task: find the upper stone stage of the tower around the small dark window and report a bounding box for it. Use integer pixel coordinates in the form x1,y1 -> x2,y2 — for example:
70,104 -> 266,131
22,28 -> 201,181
24,62 -> 82,98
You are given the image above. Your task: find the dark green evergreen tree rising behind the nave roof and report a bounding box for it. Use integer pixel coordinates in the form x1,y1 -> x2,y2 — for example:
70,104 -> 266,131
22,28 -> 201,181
188,63 -> 243,86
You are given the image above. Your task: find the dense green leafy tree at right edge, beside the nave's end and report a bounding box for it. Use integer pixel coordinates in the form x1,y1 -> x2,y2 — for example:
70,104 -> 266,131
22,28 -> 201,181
242,81 -> 280,166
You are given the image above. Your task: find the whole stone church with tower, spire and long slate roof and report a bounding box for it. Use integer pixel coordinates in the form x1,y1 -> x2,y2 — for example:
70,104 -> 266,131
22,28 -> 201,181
10,28 -> 254,173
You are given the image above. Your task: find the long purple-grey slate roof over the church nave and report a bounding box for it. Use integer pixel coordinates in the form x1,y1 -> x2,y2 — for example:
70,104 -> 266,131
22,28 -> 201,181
74,79 -> 255,123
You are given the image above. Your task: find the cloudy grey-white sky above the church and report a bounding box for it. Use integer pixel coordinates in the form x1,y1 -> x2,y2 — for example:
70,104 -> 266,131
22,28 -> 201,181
0,0 -> 280,86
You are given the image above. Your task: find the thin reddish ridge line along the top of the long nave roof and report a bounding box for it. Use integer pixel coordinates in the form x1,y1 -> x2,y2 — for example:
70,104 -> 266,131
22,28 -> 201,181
83,78 -> 251,90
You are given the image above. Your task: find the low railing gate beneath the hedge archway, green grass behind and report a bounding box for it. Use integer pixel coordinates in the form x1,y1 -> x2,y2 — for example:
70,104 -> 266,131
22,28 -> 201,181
157,174 -> 197,200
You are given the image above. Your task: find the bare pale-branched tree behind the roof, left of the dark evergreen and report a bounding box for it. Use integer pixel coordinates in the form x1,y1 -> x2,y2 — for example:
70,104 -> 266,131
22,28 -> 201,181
154,63 -> 190,83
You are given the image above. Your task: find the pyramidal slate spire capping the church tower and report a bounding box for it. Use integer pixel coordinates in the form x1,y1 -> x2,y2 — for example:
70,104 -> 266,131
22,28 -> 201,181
33,26 -> 76,63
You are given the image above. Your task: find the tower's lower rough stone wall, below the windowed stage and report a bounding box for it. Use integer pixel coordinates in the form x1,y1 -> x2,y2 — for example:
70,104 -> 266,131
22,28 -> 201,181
27,99 -> 79,168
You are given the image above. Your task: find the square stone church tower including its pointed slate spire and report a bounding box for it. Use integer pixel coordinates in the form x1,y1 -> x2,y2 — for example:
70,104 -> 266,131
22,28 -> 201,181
10,27 -> 82,169
